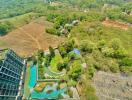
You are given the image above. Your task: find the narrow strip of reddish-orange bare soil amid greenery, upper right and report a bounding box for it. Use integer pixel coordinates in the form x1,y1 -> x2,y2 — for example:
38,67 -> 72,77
102,20 -> 131,30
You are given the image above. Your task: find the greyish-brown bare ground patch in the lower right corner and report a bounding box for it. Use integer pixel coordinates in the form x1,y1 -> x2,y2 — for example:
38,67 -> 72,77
93,71 -> 132,100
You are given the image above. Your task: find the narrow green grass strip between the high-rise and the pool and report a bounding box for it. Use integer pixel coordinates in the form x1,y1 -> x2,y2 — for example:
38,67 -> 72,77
24,66 -> 30,98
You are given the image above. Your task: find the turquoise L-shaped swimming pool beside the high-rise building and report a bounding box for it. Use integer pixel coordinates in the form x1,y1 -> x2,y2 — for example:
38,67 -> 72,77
29,65 -> 65,99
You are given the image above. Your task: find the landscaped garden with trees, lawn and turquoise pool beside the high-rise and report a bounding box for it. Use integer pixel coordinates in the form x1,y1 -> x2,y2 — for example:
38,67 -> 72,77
24,41 -> 83,99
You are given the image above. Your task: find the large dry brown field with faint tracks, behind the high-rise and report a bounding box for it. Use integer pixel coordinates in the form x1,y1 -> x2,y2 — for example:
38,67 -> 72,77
0,18 -> 64,56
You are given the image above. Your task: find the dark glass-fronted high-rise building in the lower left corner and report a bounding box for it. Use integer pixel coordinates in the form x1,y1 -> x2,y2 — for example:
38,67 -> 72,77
0,49 -> 24,100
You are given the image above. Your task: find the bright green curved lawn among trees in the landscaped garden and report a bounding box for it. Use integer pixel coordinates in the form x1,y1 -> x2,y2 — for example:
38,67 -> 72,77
50,54 -> 63,72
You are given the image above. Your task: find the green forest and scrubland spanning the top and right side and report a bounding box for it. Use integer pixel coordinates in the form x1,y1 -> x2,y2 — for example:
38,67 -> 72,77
0,0 -> 132,100
